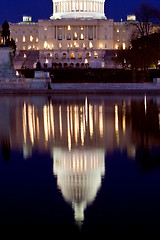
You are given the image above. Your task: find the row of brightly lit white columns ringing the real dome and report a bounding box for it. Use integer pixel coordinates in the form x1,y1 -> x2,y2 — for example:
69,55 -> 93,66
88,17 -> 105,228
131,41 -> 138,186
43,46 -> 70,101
53,0 -> 104,15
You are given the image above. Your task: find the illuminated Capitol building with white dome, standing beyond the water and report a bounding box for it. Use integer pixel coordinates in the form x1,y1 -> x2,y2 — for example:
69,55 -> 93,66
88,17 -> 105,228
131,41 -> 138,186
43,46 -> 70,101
7,0 -> 138,69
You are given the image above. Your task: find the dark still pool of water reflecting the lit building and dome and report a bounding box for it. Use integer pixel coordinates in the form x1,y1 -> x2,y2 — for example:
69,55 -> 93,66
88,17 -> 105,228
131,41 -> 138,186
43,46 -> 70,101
0,95 -> 160,236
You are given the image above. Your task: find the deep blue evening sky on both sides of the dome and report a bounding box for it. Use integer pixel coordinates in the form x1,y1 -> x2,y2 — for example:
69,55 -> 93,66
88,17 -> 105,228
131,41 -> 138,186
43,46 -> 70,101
0,0 -> 160,24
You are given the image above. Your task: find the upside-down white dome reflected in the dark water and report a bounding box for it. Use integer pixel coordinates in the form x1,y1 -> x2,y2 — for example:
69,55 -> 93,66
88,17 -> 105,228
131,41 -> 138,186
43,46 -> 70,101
53,149 -> 105,222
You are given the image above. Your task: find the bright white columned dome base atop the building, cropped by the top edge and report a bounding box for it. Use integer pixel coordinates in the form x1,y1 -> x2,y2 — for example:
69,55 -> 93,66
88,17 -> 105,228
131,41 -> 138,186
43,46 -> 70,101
51,0 -> 106,19
